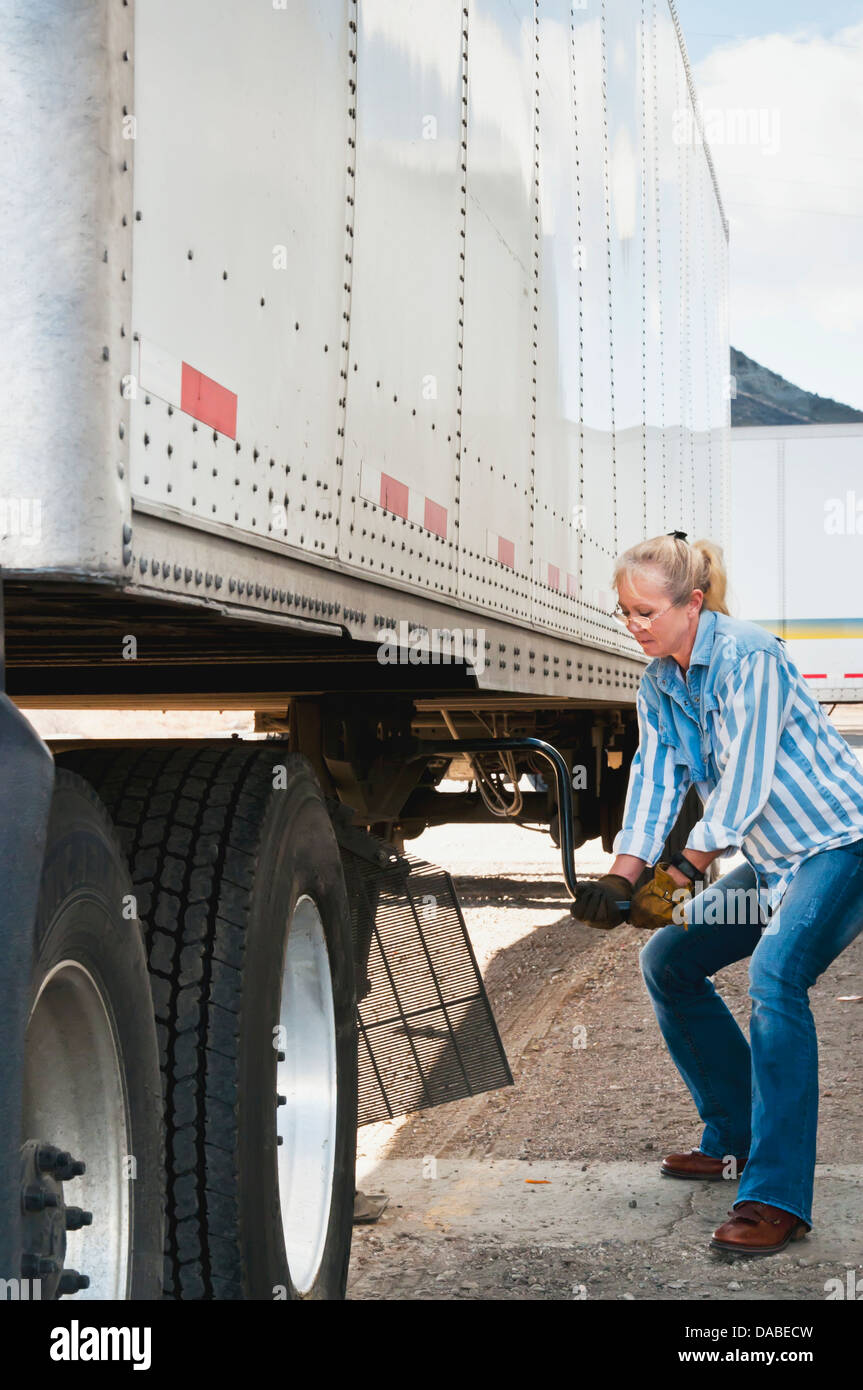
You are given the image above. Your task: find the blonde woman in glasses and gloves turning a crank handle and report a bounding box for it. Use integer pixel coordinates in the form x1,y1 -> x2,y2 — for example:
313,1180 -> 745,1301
574,531 -> 863,1255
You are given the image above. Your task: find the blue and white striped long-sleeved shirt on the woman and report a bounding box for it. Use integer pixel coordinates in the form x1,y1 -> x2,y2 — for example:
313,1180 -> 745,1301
613,609 -> 863,916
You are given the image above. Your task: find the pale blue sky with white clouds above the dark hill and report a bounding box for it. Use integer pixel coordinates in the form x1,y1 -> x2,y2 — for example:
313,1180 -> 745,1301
677,0 -> 863,410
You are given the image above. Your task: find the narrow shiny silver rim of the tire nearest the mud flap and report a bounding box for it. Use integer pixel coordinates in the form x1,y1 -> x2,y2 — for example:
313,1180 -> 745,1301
275,894 -> 338,1294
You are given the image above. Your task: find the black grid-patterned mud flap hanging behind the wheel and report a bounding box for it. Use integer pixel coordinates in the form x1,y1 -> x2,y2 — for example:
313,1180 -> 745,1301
336,826 -> 513,1125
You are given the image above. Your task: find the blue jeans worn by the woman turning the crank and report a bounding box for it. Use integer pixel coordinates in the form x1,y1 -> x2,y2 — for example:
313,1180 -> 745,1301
639,840 -> 863,1227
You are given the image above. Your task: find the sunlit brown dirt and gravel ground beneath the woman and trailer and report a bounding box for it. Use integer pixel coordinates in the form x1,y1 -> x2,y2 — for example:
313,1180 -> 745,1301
349,708 -> 863,1301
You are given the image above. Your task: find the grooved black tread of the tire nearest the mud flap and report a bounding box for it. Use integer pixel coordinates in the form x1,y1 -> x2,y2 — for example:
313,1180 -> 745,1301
60,742 -> 299,1300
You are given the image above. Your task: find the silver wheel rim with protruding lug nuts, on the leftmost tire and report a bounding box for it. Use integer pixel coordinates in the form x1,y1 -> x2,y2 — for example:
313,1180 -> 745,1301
24,960 -> 133,1300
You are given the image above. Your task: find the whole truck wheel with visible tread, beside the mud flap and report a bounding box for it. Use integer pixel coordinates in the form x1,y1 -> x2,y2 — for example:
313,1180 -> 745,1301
61,741 -> 357,1300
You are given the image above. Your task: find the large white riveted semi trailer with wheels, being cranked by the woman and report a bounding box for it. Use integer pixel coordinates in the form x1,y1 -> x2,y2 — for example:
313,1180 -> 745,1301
0,0 -> 728,1300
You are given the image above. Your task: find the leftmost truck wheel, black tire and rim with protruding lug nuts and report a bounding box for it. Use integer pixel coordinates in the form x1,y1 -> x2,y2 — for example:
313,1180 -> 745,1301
22,770 -> 164,1300
